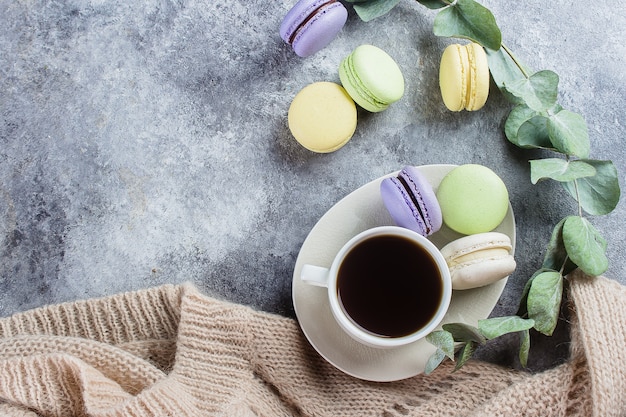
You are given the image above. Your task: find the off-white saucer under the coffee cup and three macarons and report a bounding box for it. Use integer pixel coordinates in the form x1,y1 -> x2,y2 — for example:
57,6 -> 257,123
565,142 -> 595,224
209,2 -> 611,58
292,165 -> 515,382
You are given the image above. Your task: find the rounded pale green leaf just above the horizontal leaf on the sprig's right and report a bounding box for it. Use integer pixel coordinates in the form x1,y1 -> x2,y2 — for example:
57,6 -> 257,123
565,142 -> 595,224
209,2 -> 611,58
548,110 -> 590,158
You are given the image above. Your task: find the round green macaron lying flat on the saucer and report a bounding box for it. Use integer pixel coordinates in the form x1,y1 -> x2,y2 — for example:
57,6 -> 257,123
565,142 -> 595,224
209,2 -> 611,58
437,164 -> 509,235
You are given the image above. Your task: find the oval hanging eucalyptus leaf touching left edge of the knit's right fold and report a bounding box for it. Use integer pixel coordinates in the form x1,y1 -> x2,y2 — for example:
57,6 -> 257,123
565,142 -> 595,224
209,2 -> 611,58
526,271 -> 563,336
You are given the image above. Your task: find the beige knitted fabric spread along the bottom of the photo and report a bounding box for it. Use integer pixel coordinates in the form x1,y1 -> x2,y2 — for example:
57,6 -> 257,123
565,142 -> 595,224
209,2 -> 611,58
0,270 -> 626,417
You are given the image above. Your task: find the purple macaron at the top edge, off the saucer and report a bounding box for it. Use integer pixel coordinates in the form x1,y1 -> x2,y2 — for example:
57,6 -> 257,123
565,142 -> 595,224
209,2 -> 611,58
280,0 -> 348,57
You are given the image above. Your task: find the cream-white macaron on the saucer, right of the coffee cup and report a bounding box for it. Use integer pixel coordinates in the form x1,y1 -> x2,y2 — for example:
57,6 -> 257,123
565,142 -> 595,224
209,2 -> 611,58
441,232 -> 516,290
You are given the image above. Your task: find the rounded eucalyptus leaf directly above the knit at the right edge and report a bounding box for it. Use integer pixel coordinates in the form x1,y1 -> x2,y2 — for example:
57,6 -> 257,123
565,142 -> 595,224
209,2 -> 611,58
563,216 -> 609,275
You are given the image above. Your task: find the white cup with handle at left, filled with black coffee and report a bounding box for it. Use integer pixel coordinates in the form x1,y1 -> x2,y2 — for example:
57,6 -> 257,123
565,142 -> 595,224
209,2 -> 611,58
300,226 -> 452,348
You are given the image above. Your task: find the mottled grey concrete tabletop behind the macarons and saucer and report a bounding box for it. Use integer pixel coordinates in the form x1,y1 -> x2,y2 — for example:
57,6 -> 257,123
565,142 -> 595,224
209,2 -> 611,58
0,0 -> 626,369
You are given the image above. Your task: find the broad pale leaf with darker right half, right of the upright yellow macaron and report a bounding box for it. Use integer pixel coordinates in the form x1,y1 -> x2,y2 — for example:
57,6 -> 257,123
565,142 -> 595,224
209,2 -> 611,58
505,70 -> 559,112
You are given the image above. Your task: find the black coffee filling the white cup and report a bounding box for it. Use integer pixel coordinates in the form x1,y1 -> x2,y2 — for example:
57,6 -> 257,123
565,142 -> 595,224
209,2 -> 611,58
337,235 -> 443,337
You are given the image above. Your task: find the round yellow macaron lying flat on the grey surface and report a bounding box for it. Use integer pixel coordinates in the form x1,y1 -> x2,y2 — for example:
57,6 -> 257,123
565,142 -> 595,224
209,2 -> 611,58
287,81 -> 357,153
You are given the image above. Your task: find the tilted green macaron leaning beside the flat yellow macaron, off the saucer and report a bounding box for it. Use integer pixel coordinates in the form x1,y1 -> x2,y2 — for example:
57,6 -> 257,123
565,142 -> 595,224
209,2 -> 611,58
339,45 -> 404,112
